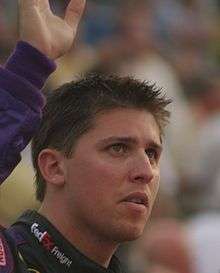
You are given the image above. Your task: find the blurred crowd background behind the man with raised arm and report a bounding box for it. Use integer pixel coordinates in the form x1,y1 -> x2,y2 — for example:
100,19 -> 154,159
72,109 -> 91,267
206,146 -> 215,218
0,0 -> 220,273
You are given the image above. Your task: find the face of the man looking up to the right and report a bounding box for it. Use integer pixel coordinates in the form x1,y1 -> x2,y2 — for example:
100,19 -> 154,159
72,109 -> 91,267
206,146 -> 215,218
62,108 -> 161,243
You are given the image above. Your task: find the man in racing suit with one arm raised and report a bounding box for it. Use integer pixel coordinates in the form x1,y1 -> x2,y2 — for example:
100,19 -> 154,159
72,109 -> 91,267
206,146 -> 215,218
0,0 -> 169,273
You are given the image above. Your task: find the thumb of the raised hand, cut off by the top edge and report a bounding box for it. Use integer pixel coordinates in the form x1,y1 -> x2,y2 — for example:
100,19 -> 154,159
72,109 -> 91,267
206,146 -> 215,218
65,0 -> 86,29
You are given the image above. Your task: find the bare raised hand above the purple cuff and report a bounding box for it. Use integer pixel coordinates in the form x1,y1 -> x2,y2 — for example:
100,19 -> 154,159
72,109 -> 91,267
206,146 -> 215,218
18,0 -> 86,59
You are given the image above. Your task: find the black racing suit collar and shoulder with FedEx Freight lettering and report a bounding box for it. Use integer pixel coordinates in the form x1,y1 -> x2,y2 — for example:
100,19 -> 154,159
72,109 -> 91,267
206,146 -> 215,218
0,211 -> 121,273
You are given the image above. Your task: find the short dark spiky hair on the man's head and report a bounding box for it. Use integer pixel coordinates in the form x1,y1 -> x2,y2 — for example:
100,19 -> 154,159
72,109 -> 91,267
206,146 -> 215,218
32,74 -> 170,201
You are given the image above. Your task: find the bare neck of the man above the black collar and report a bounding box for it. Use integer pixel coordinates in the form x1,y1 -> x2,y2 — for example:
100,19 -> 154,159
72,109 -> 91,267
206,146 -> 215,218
39,202 -> 118,268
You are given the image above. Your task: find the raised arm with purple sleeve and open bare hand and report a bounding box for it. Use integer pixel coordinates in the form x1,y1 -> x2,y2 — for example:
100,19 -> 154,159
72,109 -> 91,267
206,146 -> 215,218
0,0 -> 85,183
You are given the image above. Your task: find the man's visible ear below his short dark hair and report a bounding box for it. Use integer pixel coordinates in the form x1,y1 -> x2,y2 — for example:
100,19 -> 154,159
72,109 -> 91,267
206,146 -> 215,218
38,149 -> 65,186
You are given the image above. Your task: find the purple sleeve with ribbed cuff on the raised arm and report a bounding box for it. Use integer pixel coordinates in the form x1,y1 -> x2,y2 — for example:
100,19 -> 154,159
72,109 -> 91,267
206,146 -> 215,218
0,41 -> 56,184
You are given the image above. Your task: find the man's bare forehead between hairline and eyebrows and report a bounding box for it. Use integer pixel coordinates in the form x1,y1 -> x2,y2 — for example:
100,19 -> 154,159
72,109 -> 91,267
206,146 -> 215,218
85,108 -> 161,144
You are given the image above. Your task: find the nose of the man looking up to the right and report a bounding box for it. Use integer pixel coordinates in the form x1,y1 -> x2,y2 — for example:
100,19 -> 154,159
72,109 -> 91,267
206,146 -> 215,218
130,154 -> 154,184
